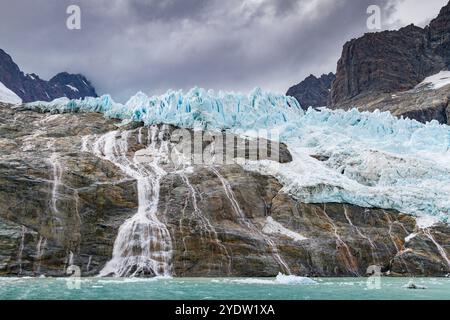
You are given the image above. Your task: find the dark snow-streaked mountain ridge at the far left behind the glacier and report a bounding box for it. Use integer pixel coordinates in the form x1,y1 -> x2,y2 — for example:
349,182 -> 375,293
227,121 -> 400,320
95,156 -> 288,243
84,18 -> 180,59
0,49 -> 97,102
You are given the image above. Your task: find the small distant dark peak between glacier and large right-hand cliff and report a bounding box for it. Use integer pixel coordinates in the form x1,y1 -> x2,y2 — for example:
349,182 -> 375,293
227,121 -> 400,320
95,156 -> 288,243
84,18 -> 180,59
286,72 -> 336,109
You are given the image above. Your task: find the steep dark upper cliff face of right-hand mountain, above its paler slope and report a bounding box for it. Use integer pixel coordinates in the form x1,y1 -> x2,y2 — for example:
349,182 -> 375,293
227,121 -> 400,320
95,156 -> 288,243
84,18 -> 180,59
331,3 -> 450,115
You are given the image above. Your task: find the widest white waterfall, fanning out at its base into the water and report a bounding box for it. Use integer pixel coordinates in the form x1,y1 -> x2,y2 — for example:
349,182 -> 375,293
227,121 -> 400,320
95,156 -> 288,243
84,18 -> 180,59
82,126 -> 172,277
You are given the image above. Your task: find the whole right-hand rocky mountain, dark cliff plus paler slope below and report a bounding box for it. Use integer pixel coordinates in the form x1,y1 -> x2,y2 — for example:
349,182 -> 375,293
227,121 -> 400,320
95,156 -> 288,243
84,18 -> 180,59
331,3 -> 450,123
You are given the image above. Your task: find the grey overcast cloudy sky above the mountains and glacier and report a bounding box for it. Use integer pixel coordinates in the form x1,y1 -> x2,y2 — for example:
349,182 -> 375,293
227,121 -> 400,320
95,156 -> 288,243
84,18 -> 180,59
0,0 -> 448,101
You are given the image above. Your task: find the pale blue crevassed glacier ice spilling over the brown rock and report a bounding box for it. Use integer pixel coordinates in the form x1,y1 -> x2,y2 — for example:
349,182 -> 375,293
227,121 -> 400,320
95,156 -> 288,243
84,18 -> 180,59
26,88 -> 450,222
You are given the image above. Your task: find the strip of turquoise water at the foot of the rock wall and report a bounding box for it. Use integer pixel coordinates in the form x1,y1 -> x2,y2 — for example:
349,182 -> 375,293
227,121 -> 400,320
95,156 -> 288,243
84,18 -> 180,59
0,278 -> 450,300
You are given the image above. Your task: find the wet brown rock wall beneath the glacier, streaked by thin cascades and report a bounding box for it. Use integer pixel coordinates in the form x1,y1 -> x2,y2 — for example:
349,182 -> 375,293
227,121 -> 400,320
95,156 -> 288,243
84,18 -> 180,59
0,104 -> 450,276
